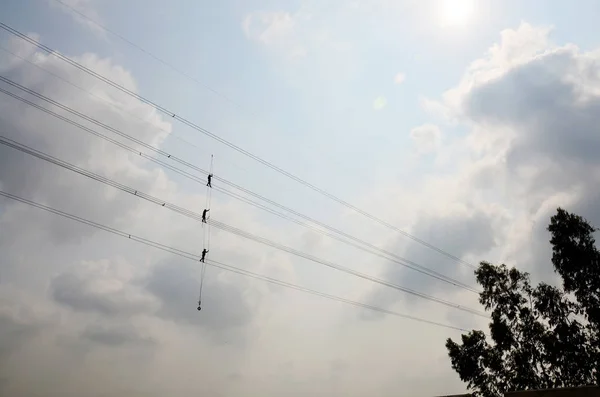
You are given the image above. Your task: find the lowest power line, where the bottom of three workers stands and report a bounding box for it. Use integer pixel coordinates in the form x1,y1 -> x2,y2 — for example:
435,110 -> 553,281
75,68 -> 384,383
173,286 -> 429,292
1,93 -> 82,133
0,190 -> 468,332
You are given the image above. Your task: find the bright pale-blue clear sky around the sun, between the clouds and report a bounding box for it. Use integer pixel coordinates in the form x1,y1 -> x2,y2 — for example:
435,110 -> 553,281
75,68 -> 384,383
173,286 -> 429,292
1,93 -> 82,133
3,0 -> 600,204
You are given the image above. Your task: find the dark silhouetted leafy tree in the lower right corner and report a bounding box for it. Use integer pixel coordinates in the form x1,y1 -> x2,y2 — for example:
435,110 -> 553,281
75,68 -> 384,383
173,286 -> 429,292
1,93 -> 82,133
446,208 -> 600,397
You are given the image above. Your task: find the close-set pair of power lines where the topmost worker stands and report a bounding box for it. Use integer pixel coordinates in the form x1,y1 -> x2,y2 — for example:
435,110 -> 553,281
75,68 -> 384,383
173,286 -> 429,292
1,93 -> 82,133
0,76 -> 479,293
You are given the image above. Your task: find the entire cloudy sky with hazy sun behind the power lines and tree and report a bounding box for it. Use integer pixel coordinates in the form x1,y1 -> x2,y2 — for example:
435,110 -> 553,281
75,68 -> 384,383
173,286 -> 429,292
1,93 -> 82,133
0,0 -> 600,397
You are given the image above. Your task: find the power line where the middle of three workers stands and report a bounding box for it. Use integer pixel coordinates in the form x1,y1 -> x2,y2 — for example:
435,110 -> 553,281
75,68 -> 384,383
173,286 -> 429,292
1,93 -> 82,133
0,136 -> 488,318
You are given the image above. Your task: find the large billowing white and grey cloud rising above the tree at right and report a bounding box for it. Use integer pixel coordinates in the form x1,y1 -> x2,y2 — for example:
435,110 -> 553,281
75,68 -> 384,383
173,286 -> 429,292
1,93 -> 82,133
354,23 -> 600,362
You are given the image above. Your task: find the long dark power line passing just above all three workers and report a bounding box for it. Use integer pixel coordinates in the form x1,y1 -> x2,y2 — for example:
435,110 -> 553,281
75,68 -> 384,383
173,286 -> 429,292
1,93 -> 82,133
0,22 -> 474,267
